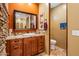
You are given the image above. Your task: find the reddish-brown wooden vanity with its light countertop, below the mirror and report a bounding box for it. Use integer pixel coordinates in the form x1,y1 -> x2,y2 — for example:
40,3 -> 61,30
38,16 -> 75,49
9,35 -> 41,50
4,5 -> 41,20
6,34 -> 45,56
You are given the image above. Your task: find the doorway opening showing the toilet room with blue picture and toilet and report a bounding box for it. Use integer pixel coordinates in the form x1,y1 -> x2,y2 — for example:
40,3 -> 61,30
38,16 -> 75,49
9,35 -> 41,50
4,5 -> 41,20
49,3 -> 67,56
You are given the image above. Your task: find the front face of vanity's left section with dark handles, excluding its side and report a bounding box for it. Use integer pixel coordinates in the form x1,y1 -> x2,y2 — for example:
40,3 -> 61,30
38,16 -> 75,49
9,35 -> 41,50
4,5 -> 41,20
10,39 -> 23,56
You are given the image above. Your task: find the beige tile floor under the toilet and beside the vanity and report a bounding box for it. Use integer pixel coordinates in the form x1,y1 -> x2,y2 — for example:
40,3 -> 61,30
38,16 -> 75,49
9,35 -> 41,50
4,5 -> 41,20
37,47 -> 66,56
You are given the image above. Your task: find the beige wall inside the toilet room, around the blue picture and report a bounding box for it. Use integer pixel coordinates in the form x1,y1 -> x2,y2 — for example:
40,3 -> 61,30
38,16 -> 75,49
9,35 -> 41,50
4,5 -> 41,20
50,4 -> 66,49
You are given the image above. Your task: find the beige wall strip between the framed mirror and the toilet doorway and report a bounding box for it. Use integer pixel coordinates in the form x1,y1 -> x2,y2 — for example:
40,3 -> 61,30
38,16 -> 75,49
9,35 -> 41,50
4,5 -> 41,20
38,3 -> 49,54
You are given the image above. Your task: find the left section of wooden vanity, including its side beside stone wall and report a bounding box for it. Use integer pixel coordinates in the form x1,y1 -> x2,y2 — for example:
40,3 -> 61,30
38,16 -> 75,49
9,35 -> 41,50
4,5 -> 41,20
6,39 -> 23,56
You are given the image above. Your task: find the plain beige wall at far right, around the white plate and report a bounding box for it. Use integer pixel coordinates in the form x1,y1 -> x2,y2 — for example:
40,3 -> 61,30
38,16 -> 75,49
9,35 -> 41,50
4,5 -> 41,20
68,3 -> 79,56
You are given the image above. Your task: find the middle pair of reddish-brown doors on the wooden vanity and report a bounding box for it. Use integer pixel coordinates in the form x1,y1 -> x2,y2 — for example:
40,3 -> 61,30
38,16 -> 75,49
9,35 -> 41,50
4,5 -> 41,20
24,37 -> 37,56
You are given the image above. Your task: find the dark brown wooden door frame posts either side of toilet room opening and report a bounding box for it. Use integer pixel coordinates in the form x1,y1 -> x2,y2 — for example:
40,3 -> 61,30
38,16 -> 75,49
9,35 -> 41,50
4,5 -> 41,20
49,3 -> 68,56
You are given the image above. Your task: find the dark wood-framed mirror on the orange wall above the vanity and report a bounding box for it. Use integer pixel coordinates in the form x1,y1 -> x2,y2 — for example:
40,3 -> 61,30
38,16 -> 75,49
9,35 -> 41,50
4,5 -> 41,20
14,10 -> 37,30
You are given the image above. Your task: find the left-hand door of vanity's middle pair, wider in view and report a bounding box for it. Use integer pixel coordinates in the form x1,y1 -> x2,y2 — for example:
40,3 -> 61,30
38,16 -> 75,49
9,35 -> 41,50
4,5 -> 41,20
24,38 -> 32,56
